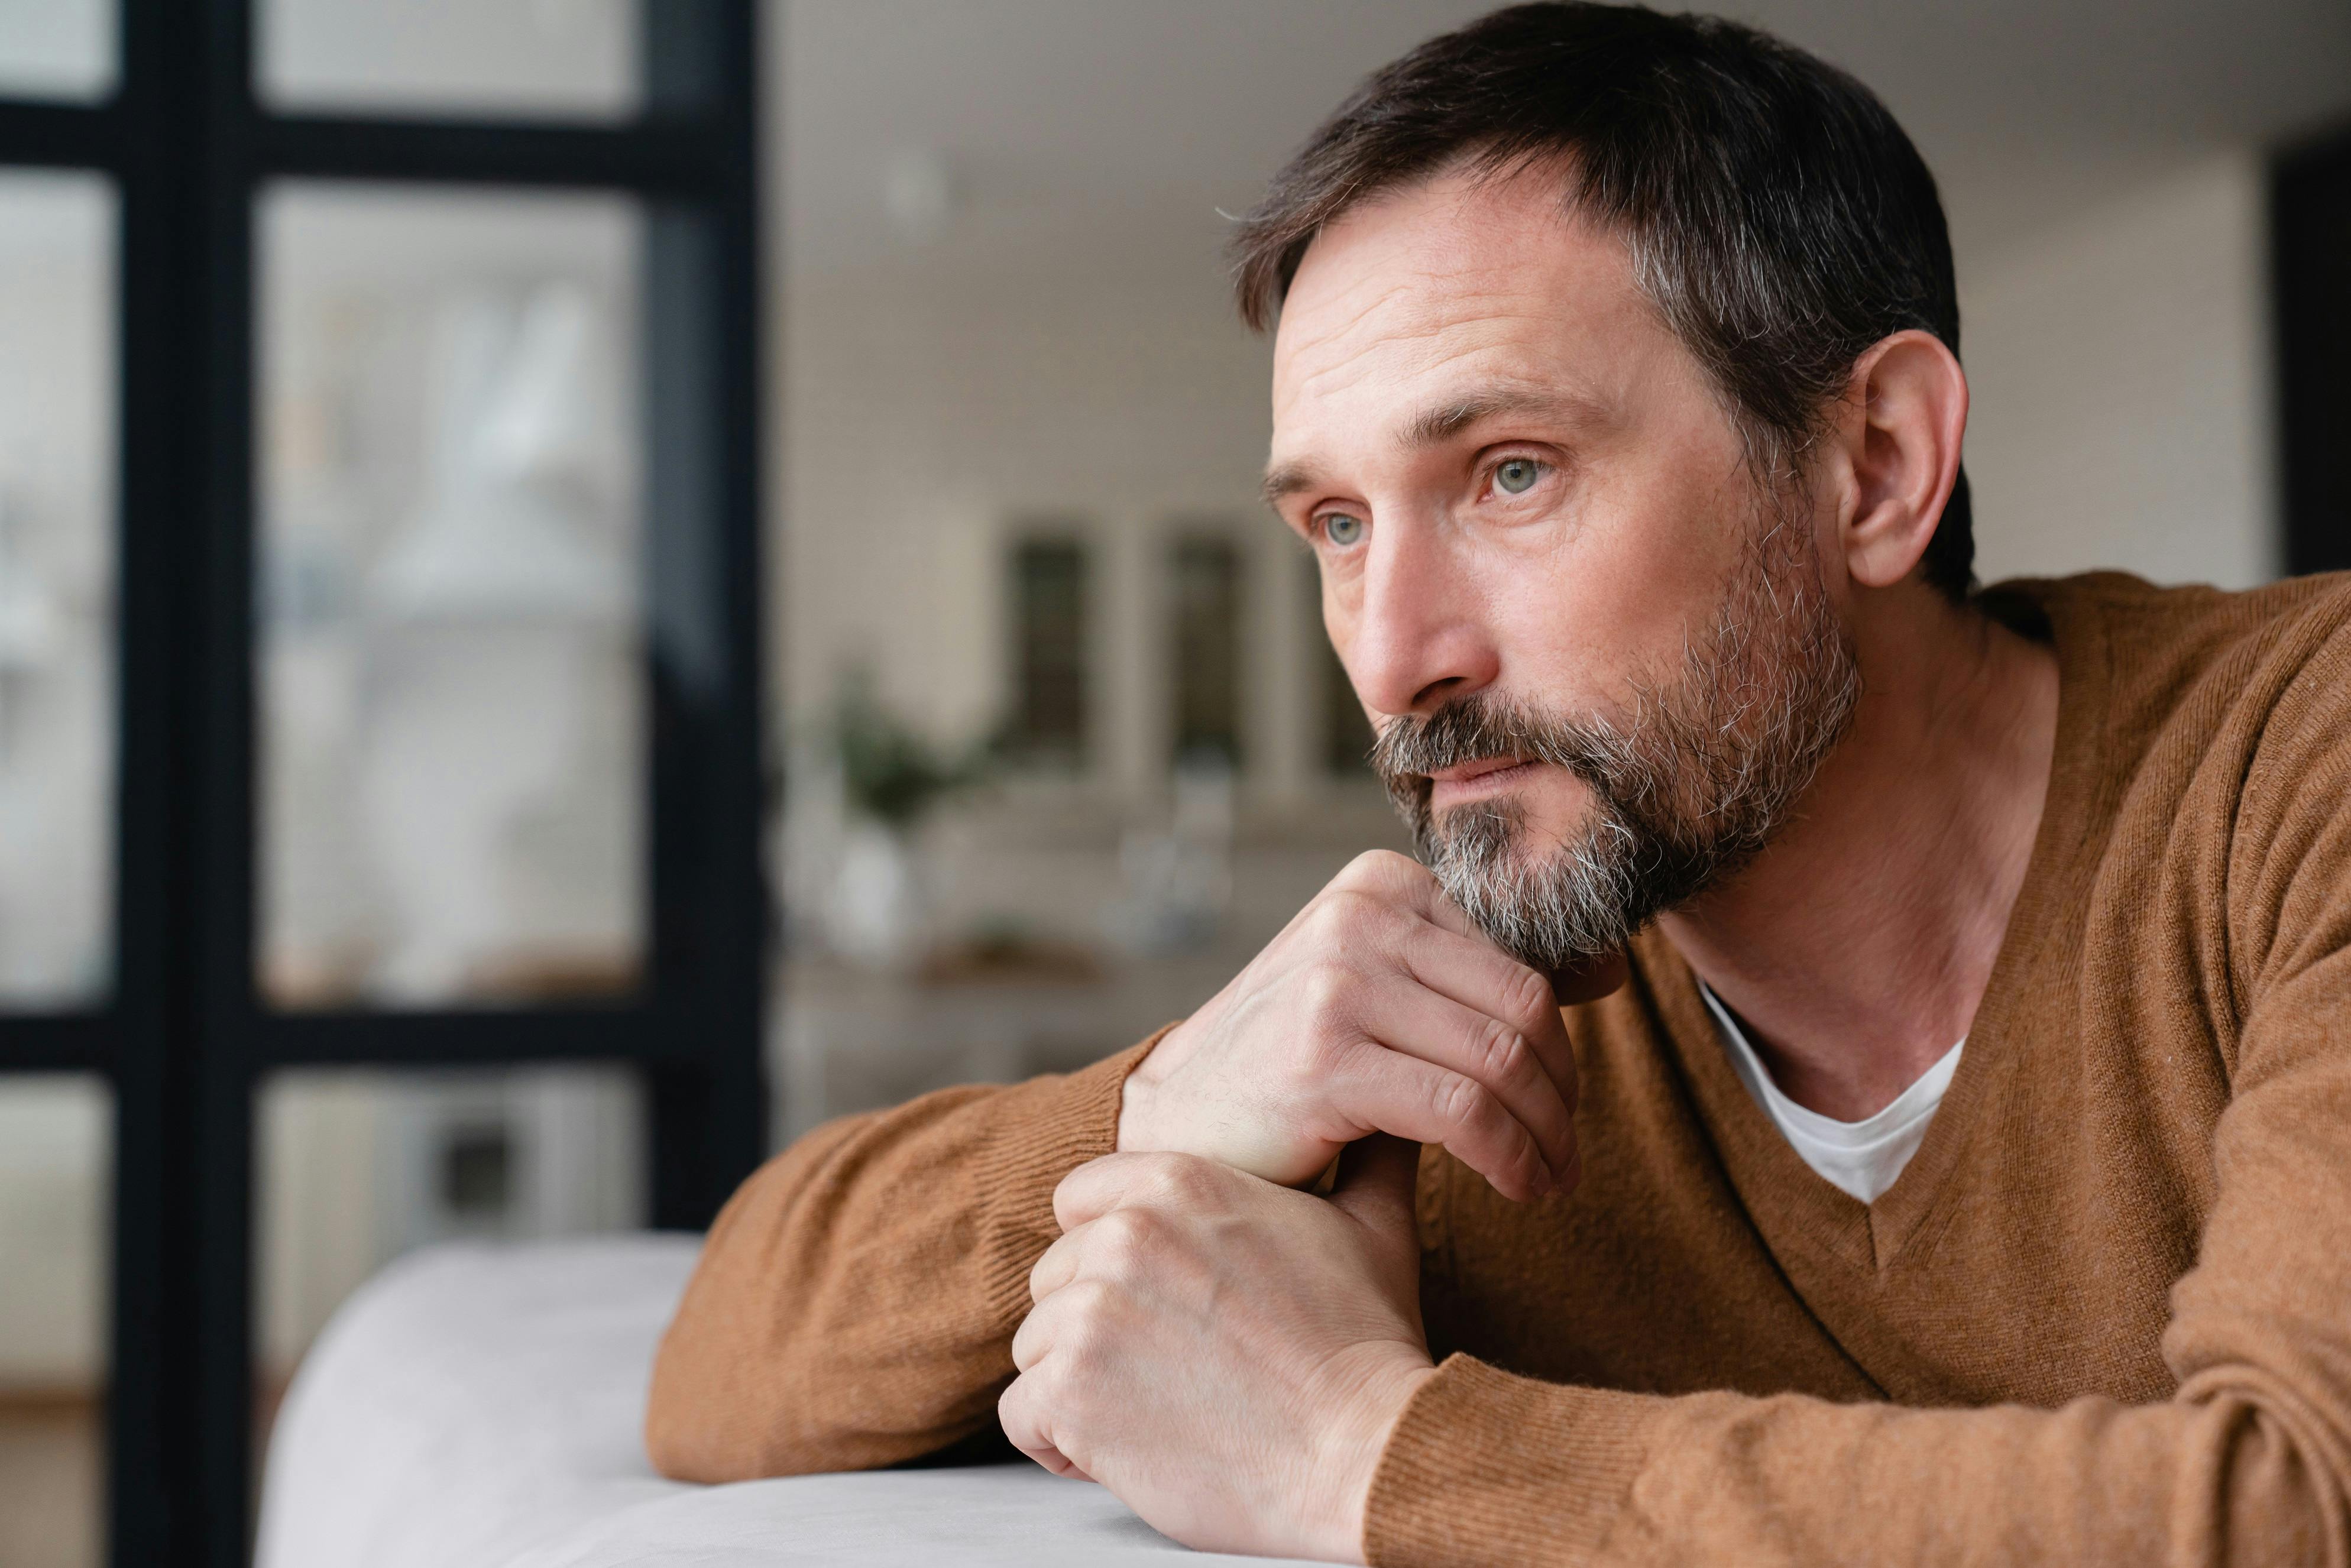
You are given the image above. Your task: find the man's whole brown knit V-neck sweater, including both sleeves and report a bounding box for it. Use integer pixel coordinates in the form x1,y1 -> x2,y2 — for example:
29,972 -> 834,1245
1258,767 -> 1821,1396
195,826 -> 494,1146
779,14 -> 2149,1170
646,574 -> 2351,1568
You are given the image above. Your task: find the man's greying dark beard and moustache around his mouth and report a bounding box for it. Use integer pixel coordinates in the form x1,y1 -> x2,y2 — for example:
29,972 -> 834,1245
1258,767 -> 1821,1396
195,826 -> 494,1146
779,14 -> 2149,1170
1371,520 -> 1862,973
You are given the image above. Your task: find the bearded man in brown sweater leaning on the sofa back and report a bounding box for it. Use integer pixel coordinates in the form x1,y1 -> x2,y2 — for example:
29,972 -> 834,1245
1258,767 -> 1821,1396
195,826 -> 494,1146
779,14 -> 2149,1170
649,5 -> 2351,1563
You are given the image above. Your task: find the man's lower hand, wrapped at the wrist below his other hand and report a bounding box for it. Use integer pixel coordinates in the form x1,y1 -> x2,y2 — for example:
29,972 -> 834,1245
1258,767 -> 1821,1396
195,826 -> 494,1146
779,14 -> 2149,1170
997,1138 -> 1432,1561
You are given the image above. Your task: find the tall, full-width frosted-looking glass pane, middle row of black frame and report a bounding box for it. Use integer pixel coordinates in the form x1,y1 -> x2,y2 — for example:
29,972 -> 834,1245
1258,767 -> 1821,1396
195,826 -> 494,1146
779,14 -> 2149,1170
258,186 -> 646,1006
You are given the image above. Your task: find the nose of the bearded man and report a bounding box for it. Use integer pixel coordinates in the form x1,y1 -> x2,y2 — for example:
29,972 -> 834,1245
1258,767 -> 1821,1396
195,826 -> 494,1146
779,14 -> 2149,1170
1330,517 -> 1502,715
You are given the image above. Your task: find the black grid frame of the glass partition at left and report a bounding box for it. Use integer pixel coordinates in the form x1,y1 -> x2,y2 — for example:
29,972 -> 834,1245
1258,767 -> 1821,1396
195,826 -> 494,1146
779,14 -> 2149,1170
0,0 -> 769,1568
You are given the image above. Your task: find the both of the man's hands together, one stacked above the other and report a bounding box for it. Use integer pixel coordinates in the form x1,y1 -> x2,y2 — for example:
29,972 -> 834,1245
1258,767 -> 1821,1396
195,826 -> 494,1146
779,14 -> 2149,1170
999,853 -> 1622,1561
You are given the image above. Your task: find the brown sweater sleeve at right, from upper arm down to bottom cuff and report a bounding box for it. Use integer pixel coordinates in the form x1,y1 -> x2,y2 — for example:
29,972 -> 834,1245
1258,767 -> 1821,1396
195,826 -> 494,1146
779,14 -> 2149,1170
1366,682 -> 2351,1568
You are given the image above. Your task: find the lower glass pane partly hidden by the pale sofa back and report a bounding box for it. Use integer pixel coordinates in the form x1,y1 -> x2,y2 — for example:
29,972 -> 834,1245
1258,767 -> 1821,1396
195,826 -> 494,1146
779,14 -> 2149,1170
255,1065 -> 646,1457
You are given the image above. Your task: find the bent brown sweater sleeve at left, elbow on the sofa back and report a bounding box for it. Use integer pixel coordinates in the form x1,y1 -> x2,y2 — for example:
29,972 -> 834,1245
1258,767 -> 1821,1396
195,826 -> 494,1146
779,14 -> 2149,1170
644,1029 -> 1164,1481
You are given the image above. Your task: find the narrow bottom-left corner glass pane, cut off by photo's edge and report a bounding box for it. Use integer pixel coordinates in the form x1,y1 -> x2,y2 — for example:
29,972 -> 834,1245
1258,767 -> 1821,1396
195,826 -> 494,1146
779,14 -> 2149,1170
0,1077 -> 113,1568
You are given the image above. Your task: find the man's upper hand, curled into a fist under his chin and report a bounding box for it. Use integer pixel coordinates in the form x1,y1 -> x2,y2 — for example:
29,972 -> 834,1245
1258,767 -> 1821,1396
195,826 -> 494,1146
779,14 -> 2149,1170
1119,851 -> 1622,1199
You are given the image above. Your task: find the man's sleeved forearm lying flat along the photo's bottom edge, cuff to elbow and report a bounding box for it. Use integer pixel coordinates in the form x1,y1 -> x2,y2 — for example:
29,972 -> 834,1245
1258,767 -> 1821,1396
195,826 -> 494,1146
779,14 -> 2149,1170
1364,1356 -> 2351,1568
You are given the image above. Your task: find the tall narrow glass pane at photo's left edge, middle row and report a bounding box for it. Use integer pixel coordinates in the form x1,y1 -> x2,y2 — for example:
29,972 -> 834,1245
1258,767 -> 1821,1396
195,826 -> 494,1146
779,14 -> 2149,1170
0,171 -> 115,1009
